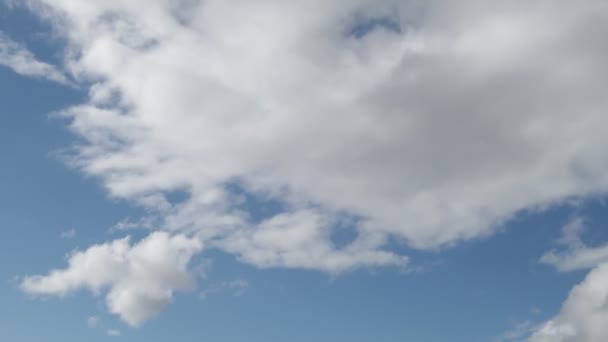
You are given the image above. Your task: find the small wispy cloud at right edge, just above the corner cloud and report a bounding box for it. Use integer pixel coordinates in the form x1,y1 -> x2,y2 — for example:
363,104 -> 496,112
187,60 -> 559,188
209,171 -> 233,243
540,218 -> 608,272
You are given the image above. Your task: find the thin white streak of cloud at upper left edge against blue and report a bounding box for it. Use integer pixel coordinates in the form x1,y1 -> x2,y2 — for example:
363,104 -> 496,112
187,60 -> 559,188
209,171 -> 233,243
0,32 -> 70,85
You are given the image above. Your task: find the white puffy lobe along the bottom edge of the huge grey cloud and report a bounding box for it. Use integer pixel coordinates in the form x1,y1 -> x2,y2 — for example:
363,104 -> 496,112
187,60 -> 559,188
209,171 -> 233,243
217,211 -> 407,273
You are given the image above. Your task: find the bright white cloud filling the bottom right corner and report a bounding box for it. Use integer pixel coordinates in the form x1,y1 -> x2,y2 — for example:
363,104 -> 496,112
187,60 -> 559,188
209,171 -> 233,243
529,263 -> 608,342
